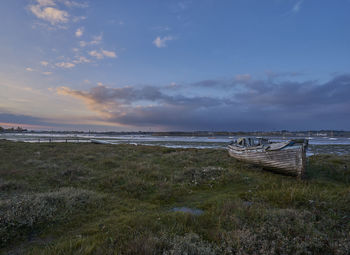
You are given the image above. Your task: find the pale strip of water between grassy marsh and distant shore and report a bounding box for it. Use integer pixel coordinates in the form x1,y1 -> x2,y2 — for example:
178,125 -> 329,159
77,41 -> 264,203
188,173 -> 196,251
0,132 -> 350,156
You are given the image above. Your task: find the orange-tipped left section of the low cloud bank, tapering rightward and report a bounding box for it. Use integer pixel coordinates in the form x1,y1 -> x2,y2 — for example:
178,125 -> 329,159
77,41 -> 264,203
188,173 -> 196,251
57,84 -> 229,126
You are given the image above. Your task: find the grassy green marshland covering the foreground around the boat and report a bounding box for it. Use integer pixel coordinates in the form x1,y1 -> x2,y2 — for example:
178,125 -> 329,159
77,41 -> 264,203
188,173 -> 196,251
0,141 -> 350,254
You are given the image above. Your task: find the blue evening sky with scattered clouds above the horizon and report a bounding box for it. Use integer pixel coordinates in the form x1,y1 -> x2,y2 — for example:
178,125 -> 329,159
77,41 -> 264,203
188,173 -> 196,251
0,0 -> 350,131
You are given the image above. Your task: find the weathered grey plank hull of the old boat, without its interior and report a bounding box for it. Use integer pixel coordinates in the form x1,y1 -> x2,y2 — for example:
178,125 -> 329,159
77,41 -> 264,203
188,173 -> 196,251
228,144 -> 306,178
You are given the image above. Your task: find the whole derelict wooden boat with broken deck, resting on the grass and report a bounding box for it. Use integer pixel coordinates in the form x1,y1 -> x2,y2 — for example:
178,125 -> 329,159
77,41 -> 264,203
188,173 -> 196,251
228,137 -> 308,178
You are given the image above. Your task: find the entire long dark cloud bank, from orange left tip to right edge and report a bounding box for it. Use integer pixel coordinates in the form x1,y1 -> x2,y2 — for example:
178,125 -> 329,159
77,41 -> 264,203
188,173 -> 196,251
58,75 -> 350,130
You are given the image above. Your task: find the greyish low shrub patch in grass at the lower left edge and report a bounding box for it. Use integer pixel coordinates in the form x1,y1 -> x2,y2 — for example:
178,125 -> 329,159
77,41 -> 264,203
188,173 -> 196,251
0,188 -> 101,246
